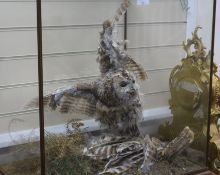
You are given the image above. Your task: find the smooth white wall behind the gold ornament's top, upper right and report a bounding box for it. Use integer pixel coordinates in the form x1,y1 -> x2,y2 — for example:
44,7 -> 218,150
187,0 -> 220,76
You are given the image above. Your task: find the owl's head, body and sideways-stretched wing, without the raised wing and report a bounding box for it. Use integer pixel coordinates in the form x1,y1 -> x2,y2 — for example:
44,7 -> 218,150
29,69 -> 142,136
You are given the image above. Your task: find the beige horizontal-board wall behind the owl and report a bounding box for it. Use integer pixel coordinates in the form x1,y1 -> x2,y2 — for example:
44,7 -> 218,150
0,0 -> 186,134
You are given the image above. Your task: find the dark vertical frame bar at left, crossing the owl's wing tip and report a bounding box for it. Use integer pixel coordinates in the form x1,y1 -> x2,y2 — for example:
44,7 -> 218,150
36,0 -> 45,175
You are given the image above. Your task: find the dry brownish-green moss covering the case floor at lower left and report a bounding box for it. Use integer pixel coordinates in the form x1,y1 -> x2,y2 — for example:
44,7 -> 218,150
0,133 -> 106,175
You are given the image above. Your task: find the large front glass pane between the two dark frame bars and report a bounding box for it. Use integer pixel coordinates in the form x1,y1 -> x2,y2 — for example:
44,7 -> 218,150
42,0 -> 213,175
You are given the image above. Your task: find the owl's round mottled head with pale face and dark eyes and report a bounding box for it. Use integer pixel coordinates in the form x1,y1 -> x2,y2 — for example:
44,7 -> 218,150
97,69 -> 139,106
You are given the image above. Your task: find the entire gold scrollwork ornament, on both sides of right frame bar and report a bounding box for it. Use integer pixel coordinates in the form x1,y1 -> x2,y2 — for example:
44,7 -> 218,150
159,27 -> 220,174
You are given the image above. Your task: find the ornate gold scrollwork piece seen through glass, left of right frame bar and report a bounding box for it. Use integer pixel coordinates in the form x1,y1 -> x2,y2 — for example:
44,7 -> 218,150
159,27 -> 210,150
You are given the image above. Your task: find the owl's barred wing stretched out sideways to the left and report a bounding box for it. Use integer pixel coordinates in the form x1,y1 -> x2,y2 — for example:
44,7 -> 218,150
28,84 -> 97,116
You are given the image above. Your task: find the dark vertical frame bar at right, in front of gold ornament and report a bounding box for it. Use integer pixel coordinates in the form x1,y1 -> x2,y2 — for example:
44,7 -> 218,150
206,0 -> 216,168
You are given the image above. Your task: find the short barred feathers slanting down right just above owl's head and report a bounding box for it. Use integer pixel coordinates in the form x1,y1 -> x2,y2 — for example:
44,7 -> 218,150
121,56 -> 147,80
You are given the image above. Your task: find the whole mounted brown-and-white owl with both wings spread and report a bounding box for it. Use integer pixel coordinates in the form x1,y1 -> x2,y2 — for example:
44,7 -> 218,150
29,0 -> 146,135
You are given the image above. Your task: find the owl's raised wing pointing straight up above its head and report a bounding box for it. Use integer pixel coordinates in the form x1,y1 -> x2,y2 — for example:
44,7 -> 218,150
97,0 -> 147,80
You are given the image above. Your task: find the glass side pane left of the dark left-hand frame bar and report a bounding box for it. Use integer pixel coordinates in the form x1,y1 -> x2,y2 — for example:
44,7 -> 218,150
0,1 -> 40,175
